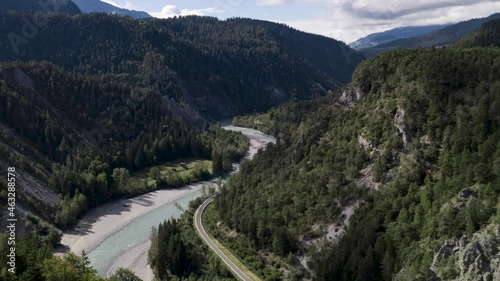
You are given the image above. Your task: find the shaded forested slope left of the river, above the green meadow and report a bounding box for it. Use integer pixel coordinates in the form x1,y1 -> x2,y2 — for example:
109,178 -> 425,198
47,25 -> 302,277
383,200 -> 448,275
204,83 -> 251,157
0,62 -> 248,228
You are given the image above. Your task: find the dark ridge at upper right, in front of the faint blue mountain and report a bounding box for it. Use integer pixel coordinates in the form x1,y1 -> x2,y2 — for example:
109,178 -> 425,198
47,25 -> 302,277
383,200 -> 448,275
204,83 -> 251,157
361,14 -> 500,57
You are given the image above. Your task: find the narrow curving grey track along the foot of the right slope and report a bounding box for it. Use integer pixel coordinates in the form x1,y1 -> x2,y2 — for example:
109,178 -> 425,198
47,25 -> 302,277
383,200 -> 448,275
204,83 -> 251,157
194,198 -> 252,281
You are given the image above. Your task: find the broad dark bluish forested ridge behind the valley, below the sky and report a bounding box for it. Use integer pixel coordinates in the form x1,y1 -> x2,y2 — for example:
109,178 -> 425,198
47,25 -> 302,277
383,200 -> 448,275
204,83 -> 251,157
0,13 -> 363,119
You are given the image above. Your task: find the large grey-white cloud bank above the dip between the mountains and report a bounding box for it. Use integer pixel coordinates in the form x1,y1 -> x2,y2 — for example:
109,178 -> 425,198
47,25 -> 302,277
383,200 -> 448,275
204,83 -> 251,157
272,0 -> 500,43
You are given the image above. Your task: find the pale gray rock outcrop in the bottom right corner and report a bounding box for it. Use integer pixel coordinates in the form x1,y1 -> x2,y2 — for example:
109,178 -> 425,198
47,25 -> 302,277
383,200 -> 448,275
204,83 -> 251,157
431,224 -> 500,281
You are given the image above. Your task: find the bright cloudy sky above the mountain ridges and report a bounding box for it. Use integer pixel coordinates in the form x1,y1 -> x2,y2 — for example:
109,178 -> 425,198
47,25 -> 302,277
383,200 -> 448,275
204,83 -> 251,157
101,0 -> 500,43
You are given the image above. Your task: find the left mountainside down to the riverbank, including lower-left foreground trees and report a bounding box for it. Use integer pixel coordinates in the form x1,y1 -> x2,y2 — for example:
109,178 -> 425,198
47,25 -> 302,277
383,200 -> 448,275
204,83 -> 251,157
0,59 -> 249,281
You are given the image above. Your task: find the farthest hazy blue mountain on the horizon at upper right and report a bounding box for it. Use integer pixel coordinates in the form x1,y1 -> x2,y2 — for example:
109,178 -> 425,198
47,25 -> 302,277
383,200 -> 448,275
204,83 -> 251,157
349,25 -> 446,50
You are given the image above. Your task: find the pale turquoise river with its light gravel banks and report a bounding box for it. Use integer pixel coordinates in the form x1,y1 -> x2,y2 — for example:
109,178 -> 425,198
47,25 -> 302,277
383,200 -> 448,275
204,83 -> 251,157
61,125 -> 276,281
